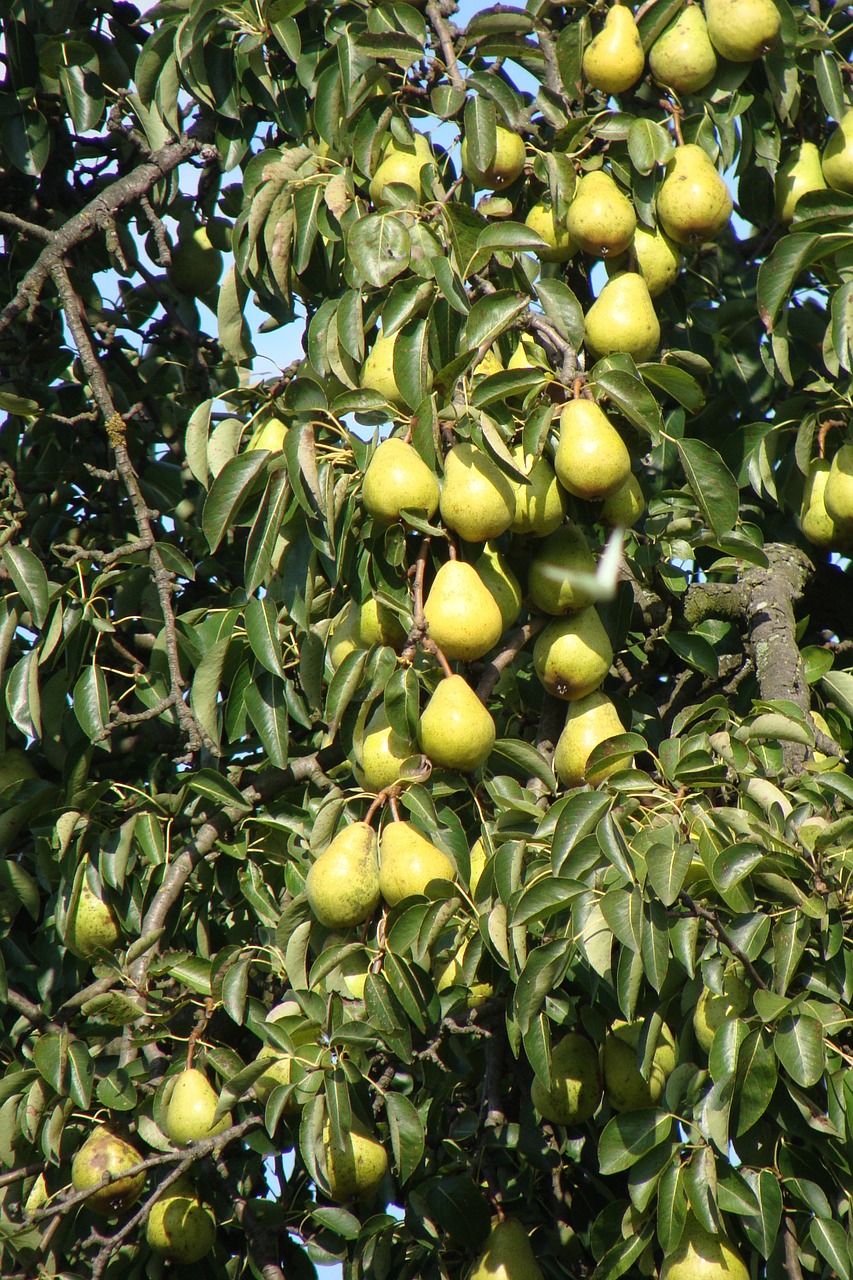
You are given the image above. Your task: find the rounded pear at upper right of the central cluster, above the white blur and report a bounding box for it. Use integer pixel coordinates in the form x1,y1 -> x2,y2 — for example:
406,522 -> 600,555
555,399 -> 631,499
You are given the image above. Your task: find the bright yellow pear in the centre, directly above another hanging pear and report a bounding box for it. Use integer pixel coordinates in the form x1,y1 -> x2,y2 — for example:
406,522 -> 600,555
424,561 -> 503,662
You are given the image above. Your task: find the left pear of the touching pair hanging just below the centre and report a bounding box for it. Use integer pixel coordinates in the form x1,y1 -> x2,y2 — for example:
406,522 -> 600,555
305,822 -> 379,929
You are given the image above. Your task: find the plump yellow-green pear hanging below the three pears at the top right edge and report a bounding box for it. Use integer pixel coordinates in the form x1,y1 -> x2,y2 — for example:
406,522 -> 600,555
657,144 -> 732,244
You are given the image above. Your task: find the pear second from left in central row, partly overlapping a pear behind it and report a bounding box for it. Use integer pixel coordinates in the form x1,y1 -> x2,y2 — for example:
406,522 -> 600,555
441,442 -> 515,543
